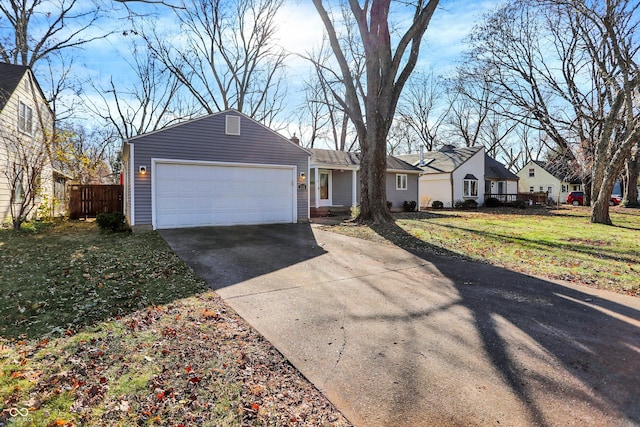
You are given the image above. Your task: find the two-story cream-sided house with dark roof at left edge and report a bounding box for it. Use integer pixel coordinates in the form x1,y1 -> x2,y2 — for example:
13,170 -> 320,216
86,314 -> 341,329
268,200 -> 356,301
0,63 -> 64,223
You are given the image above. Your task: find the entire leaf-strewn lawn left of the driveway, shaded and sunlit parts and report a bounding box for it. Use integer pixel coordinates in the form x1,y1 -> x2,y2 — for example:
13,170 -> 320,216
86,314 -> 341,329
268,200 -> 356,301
0,222 -> 349,427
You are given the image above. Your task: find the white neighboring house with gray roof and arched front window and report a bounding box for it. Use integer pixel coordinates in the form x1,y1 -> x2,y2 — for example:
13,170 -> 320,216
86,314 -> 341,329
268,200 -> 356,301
398,145 -> 518,208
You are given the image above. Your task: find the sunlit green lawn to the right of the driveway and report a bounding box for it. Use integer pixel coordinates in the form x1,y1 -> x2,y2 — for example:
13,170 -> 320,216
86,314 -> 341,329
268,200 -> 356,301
329,207 -> 640,295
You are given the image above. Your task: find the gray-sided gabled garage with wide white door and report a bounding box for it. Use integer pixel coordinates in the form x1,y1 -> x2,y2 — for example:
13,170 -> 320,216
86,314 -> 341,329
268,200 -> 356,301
122,110 -> 310,229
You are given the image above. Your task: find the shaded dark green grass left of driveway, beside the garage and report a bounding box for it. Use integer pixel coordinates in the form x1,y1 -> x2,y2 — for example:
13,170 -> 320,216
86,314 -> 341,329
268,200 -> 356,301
0,222 -> 206,338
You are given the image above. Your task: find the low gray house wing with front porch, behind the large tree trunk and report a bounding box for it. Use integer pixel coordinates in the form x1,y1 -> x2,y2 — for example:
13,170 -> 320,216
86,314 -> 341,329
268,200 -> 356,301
309,148 -> 422,216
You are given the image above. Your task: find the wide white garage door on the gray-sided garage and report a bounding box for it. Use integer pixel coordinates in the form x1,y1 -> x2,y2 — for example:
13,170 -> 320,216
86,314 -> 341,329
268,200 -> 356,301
153,163 -> 296,228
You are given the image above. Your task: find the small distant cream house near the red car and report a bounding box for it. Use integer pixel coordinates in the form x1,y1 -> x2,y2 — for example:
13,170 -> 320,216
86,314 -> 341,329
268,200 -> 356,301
516,160 -> 583,203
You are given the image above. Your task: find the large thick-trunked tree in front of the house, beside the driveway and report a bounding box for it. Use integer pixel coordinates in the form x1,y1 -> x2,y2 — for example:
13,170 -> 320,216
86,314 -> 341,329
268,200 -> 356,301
313,0 -> 438,223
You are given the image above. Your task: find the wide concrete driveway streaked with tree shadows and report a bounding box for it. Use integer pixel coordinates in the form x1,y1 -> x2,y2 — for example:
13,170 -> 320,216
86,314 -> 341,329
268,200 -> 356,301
161,224 -> 640,427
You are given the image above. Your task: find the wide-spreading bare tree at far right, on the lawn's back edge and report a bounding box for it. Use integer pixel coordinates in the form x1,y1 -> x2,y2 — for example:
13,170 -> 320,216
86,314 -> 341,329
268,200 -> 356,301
460,0 -> 640,223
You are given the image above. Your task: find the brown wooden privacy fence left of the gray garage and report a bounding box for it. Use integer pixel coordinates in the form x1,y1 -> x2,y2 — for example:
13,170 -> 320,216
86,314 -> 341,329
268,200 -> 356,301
69,185 -> 123,219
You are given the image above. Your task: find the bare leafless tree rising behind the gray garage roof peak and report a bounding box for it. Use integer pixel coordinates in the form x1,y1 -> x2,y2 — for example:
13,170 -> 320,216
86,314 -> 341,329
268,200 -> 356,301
138,0 -> 286,126
